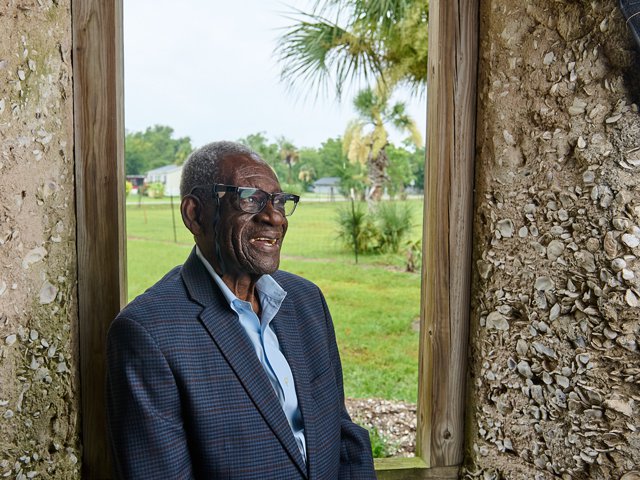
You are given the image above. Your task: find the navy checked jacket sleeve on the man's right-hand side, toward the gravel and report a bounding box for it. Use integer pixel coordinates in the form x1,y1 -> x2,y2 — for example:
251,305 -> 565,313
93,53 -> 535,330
320,293 -> 376,480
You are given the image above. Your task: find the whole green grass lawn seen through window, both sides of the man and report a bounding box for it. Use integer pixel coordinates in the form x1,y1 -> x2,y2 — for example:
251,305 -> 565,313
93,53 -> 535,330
127,199 -> 422,402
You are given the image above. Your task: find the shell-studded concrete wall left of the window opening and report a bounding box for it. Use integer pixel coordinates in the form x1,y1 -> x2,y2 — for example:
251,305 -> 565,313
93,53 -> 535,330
0,0 -> 80,479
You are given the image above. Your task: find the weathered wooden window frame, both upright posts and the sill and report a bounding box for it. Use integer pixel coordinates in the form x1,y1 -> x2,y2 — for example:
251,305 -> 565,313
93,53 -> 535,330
71,0 -> 478,480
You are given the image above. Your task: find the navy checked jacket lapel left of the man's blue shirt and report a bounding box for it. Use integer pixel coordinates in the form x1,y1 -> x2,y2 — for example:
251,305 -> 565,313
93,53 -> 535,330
182,251 -> 306,476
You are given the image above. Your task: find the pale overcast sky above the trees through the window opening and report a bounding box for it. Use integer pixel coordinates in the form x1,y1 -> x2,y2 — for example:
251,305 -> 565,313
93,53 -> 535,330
124,0 -> 426,147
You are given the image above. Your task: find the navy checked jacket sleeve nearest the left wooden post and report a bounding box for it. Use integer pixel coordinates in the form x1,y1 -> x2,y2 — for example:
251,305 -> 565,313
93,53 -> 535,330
106,317 -> 193,480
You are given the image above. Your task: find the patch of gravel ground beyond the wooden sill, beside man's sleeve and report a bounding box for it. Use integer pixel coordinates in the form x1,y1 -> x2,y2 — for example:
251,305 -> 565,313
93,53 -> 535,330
346,398 -> 416,457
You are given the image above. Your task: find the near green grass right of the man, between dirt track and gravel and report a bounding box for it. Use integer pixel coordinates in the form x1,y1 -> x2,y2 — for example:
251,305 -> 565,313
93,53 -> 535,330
282,258 -> 420,401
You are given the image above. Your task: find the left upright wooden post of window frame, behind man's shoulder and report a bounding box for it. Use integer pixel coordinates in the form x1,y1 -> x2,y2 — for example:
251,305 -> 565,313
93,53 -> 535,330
72,0 -> 126,479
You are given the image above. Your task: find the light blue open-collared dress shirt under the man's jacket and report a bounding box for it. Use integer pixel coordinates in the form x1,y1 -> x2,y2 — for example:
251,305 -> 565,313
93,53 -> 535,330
196,247 -> 307,462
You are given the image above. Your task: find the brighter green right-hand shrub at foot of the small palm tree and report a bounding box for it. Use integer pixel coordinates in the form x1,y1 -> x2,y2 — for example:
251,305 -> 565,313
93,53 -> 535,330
374,202 -> 412,253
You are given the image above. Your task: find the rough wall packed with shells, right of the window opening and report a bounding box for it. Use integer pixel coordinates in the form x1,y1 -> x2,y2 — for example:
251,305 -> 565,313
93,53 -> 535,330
465,0 -> 640,480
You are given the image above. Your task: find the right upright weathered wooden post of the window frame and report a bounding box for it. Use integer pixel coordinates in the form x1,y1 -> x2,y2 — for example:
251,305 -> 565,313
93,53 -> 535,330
416,0 -> 478,467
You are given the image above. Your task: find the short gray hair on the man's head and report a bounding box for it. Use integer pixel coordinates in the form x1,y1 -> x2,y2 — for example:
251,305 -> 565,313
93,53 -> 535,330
180,141 -> 268,197
